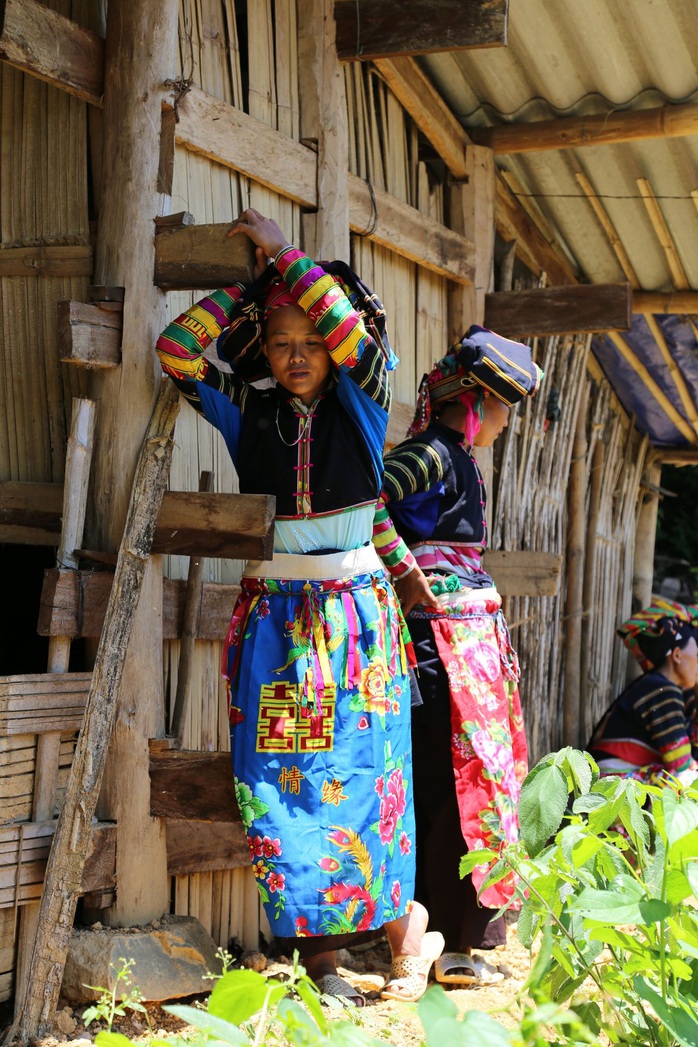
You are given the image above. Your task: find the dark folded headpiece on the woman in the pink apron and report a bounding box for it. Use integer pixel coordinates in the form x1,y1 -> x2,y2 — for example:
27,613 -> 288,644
409,325 -> 543,433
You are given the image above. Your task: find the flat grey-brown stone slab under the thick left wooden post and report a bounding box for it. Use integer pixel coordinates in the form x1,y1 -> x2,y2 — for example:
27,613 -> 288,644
61,916 -> 221,1004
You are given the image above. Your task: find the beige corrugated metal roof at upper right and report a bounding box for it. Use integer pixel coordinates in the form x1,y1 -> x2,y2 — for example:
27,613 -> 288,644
419,0 -> 698,445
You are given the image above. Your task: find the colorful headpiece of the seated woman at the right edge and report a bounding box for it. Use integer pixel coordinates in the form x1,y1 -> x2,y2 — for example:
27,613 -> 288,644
615,598 -> 698,672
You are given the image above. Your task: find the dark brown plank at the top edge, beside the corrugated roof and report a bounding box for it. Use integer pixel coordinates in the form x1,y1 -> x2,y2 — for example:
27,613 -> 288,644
335,0 -> 509,61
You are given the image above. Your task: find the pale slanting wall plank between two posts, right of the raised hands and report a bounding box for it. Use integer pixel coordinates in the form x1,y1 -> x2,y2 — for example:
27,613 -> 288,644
347,174 -> 474,284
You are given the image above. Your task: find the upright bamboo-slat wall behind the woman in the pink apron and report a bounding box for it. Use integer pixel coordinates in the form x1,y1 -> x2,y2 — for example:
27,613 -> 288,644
486,337 -> 647,763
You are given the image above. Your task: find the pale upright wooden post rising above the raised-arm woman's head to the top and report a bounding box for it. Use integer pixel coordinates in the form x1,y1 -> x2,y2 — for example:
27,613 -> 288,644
298,0 -> 350,262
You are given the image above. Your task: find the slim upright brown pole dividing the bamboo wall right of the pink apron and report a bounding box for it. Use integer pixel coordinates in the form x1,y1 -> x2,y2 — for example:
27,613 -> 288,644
561,377 -> 589,747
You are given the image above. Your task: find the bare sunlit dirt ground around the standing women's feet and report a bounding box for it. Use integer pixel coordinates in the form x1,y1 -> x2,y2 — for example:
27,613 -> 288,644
0,925 -> 531,1047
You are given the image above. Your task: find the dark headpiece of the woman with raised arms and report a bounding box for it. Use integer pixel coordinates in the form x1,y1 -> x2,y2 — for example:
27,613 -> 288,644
217,261 -> 398,382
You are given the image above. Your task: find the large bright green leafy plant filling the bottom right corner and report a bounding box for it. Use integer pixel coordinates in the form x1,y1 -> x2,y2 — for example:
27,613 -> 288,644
460,749 -> 698,1047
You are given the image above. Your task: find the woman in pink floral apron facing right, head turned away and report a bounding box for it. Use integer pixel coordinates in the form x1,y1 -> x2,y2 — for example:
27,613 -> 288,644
375,327 -> 542,984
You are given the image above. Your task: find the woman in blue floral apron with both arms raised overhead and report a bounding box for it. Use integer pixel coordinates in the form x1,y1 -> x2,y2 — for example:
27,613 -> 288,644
157,208 -> 443,1004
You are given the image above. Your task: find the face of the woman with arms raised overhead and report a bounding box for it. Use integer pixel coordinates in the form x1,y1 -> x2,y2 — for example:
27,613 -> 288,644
262,306 -> 332,407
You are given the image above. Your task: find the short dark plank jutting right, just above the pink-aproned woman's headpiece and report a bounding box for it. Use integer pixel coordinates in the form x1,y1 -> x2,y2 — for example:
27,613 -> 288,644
485,284 -> 632,338
